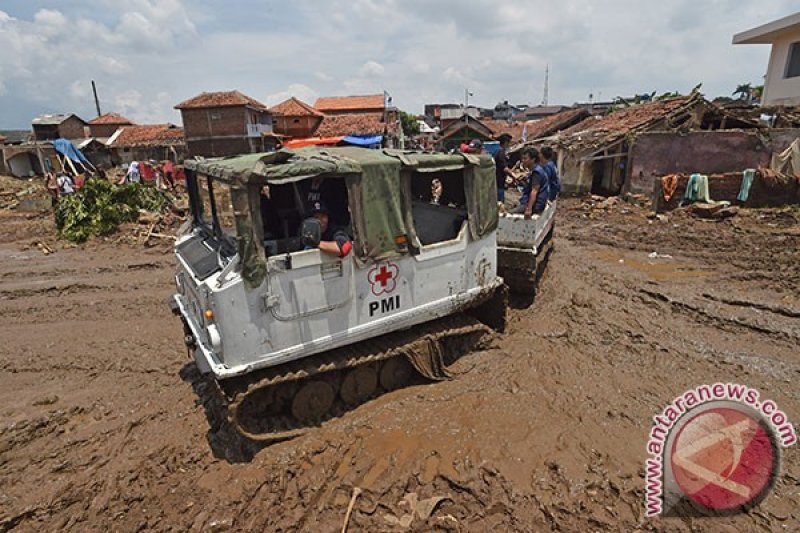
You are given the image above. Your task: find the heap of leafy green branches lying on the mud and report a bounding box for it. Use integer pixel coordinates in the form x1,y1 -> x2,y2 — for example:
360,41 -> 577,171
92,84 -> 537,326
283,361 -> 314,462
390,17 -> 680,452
55,178 -> 170,242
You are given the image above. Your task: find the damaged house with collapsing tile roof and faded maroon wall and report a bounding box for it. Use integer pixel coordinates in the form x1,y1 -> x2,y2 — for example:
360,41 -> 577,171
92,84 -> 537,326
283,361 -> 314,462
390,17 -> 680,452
528,92 -> 796,195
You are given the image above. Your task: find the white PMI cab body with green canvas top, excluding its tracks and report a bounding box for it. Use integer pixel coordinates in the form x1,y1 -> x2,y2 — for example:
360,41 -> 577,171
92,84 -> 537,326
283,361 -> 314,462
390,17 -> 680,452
172,148 -> 502,379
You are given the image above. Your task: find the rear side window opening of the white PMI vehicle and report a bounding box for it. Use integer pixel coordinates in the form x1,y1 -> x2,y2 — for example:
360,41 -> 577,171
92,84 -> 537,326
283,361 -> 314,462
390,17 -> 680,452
411,170 -> 467,246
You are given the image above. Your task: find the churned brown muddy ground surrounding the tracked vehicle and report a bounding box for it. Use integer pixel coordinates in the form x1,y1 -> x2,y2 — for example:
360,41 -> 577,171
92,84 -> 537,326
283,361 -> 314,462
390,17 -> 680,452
0,192 -> 800,531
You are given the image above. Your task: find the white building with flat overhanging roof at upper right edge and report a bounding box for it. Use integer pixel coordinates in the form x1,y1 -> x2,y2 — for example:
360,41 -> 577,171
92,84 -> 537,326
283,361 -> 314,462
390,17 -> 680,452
733,13 -> 800,106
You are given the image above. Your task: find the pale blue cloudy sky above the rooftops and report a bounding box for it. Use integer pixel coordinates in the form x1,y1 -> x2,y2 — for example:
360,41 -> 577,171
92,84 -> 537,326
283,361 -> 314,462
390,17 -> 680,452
0,0 -> 797,129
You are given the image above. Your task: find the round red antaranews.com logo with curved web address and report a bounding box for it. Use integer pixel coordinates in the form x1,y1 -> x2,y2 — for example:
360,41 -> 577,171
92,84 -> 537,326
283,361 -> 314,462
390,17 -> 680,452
645,383 -> 797,517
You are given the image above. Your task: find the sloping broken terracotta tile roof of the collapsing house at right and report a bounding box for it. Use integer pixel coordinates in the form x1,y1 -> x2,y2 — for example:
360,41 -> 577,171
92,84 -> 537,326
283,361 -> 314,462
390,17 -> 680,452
561,94 -> 703,138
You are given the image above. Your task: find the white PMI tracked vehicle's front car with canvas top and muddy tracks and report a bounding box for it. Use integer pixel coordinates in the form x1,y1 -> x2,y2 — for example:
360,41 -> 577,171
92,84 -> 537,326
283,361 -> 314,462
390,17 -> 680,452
171,148 -> 505,441
